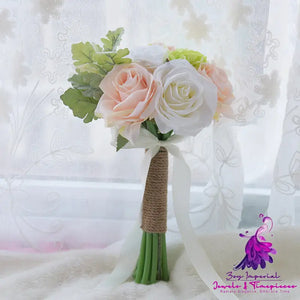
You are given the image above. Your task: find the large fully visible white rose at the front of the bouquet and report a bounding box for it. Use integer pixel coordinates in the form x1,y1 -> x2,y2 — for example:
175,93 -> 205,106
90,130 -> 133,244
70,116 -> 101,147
153,59 -> 218,135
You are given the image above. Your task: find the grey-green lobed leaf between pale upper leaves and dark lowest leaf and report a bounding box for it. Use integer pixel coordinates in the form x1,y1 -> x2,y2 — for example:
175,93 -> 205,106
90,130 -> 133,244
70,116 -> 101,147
68,72 -> 103,100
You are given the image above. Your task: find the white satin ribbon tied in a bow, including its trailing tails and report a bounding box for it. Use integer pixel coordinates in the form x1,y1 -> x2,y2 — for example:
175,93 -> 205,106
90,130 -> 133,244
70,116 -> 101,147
100,129 -> 238,300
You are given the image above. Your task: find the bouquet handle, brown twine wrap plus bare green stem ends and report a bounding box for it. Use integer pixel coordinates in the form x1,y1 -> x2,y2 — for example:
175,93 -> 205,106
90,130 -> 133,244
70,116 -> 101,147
133,147 -> 169,284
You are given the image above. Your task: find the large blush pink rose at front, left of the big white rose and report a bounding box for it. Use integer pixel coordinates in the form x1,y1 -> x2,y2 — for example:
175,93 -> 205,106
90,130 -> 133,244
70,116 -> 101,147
95,63 -> 161,141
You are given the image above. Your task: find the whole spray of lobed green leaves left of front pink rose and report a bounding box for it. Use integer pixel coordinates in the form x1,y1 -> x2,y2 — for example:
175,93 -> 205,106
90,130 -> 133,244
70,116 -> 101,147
61,28 -> 131,123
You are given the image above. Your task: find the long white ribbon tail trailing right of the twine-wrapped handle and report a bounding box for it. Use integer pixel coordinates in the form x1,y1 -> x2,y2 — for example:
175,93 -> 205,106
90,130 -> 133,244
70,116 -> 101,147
170,154 -> 238,300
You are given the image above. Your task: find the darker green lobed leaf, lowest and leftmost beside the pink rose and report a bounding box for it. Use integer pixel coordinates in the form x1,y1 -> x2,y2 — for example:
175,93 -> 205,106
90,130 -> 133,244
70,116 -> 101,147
60,88 -> 98,123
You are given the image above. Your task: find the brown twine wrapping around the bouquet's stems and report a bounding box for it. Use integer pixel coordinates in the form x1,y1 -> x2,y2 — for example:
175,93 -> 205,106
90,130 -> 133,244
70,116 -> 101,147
141,147 -> 168,233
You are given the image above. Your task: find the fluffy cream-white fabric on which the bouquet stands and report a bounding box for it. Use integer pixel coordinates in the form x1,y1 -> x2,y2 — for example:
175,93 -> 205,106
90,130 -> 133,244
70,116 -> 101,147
0,228 -> 300,300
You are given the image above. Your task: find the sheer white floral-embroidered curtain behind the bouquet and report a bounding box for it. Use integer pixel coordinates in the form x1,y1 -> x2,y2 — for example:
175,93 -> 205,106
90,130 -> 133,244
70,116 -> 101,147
0,0 -> 300,251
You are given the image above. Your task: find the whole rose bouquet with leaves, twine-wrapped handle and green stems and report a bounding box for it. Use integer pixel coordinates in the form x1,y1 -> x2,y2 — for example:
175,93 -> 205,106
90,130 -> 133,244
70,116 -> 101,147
61,28 -> 234,284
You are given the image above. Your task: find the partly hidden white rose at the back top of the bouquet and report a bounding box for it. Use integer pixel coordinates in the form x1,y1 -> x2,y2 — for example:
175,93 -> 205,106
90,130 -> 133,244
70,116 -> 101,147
130,45 -> 168,71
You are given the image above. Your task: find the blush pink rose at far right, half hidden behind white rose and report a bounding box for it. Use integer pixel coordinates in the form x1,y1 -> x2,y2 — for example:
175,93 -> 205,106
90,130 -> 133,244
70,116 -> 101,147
198,63 -> 234,119
